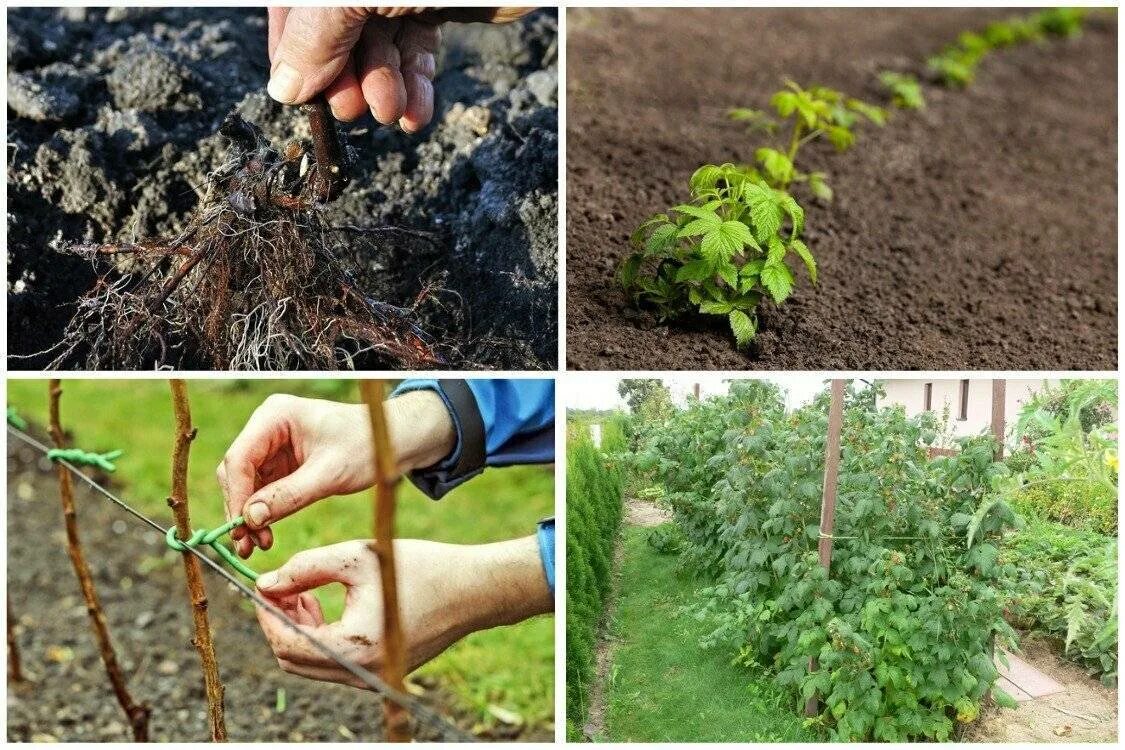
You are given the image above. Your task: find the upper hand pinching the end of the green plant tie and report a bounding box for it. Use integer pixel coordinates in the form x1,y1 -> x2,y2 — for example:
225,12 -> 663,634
215,390 -> 457,558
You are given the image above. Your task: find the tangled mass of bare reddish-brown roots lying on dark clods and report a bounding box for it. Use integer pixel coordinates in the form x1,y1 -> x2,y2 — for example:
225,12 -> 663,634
47,115 -> 443,370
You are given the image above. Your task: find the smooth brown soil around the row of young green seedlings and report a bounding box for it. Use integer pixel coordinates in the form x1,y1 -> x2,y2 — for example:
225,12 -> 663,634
567,8 -> 1117,370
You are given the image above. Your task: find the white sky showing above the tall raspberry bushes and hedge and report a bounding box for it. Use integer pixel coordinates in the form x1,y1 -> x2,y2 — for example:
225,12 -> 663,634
559,372 -> 855,409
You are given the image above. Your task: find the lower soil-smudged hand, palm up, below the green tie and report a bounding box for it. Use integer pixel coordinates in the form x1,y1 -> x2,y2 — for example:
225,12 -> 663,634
258,536 -> 555,687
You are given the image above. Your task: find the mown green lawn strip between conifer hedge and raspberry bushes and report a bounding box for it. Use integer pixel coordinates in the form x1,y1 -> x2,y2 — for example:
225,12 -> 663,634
597,526 -> 817,742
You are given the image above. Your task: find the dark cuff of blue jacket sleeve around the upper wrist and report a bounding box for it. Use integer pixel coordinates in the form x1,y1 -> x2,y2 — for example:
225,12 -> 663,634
394,380 -> 486,500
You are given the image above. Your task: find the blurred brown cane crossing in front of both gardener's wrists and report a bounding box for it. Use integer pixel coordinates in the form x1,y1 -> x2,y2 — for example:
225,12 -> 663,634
360,380 -> 411,742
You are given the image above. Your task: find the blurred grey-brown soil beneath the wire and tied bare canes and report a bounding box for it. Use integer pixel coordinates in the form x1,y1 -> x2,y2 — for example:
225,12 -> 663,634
8,441 -> 551,742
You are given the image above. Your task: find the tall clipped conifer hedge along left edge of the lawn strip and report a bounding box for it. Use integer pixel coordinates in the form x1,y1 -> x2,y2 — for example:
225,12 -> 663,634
566,427 -> 622,739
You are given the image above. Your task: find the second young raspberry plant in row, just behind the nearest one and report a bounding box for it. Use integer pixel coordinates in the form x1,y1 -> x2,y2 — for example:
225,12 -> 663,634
729,81 -> 887,201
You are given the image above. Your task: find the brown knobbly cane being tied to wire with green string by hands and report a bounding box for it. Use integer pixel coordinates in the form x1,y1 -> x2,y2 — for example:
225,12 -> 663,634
168,380 -> 226,742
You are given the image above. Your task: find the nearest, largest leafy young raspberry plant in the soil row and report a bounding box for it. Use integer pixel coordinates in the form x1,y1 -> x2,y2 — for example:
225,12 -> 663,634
618,164 -> 817,347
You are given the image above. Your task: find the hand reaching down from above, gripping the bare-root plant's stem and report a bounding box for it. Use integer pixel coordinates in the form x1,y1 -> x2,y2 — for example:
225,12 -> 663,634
268,8 -> 528,133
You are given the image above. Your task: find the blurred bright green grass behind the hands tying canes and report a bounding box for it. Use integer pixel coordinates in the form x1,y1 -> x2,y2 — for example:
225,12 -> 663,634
8,380 -> 555,725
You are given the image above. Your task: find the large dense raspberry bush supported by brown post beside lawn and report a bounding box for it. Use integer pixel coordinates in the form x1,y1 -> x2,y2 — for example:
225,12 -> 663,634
639,396 -> 1017,741
